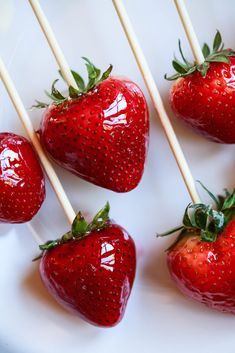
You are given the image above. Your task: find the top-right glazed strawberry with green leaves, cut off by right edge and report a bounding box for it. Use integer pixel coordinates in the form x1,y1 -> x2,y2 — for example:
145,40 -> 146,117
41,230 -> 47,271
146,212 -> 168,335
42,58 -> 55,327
165,32 -> 235,144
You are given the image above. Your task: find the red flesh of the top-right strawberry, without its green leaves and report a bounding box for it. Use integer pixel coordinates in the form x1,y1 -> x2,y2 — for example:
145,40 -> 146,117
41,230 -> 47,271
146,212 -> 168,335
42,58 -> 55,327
170,57 -> 235,144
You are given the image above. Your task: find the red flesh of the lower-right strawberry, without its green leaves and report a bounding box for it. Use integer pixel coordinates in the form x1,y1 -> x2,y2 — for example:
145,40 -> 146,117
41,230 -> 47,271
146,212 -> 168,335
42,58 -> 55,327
167,218 -> 235,314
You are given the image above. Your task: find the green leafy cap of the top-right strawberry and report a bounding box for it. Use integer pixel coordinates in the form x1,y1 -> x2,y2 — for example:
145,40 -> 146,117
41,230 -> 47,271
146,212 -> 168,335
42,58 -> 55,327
164,31 -> 235,81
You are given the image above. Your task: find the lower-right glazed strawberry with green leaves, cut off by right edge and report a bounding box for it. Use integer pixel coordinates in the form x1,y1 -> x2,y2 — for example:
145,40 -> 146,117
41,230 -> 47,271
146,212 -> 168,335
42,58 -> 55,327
158,183 -> 235,314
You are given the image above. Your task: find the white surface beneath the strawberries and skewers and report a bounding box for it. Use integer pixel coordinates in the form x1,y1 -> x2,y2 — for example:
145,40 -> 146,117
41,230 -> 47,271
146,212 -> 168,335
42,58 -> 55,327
0,0 -> 235,353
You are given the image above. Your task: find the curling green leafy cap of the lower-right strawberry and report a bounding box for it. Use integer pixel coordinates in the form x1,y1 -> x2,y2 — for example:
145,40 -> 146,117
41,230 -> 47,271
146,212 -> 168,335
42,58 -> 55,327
157,182 -> 235,244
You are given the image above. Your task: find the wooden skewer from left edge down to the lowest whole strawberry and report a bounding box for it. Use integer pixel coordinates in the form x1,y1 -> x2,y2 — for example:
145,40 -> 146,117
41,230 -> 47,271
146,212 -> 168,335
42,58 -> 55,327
0,58 -> 76,224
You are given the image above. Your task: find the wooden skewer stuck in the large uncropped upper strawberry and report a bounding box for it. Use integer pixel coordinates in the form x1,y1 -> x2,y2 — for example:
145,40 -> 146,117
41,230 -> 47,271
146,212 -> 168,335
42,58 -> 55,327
29,0 -> 77,88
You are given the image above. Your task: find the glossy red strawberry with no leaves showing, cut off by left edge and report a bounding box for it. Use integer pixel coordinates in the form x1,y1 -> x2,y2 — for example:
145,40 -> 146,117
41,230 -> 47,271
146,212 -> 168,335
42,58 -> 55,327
0,132 -> 45,223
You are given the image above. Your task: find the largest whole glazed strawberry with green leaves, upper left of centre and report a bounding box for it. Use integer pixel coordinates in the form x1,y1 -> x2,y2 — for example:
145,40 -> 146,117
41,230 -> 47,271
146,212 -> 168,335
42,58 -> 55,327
37,58 -> 149,192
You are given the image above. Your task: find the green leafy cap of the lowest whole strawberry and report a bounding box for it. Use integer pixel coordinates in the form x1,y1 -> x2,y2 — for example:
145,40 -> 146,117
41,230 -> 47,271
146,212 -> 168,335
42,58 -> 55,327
33,202 -> 110,261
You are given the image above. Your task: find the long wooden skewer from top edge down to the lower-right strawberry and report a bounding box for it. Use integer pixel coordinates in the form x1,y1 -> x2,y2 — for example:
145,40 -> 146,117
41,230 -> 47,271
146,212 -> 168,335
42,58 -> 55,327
113,0 -> 200,203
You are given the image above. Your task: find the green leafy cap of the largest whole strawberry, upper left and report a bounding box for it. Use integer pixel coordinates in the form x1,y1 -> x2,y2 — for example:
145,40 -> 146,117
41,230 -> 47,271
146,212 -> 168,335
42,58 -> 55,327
33,57 -> 113,108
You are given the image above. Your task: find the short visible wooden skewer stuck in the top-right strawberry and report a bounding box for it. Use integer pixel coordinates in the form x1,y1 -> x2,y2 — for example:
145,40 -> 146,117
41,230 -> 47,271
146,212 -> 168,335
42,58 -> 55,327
174,0 -> 205,65
